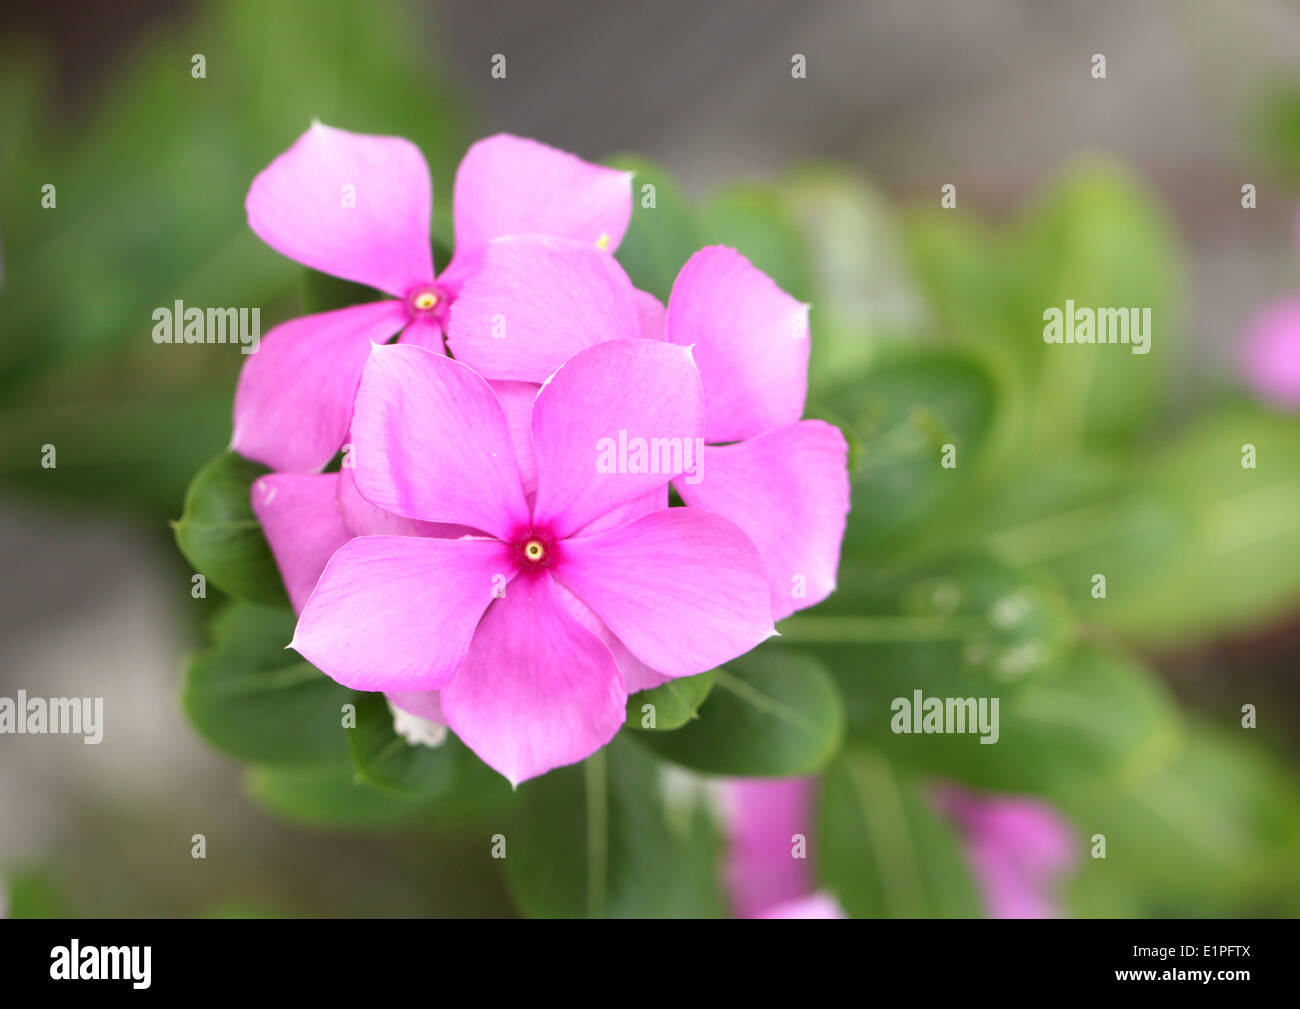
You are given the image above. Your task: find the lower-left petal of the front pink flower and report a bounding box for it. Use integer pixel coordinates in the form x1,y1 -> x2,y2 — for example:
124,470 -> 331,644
293,536 -> 517,690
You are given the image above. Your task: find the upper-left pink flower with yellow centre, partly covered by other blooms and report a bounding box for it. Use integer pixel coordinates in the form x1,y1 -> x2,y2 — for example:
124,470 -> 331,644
239,124 -> 632,472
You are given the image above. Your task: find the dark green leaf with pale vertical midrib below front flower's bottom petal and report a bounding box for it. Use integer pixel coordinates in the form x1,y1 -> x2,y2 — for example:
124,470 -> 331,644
506,733 -> 719,918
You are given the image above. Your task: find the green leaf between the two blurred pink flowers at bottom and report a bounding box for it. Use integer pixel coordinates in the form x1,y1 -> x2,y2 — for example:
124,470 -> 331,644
818,749 -> 980,918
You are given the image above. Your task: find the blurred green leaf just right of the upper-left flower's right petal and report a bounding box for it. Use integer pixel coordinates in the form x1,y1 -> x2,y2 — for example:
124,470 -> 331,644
610,156 -> 701,303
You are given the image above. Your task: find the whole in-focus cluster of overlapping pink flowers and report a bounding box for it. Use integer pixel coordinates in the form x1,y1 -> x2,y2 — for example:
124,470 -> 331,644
231,124 -> 849,783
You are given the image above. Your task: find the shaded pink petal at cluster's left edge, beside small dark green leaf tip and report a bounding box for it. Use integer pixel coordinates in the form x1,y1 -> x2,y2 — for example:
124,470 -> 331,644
250,473 -> 352,612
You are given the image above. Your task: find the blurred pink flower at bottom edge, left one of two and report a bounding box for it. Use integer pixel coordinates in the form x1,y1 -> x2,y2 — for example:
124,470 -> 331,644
723,778 -> 846,918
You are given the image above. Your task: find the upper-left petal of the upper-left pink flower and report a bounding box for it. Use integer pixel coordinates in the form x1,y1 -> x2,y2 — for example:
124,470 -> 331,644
244,122 -> 433,298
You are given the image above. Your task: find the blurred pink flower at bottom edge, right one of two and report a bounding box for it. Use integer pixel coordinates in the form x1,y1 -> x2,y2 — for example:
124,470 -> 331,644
933,785 -> 1078,918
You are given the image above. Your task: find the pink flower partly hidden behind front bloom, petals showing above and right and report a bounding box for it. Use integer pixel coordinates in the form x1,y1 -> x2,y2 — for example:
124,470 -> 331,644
447,237 -> 849,620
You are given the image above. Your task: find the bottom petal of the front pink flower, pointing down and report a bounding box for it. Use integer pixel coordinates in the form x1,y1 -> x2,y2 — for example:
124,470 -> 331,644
441,573 -> 628,784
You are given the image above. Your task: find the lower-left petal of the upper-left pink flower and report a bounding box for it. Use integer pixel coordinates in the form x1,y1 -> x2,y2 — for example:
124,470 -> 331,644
230,302 -> 406,472
